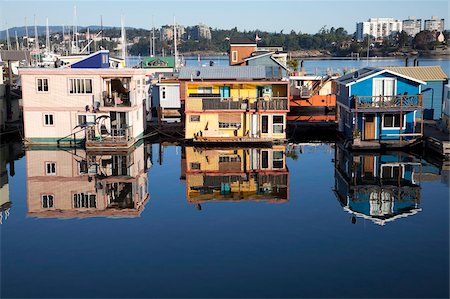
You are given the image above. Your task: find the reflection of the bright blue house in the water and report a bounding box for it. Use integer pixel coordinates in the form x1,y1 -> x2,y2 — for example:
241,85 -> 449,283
335,145 -> 422,225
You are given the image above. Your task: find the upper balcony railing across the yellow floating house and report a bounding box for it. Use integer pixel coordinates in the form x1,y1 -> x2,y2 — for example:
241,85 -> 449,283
186,97 -> 289,111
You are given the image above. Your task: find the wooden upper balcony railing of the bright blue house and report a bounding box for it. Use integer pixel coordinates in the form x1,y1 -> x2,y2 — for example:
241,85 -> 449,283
354,94 -> 423,110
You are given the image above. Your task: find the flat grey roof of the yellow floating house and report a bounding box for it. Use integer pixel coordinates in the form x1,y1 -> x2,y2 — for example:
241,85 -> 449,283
179,65 -> 266,80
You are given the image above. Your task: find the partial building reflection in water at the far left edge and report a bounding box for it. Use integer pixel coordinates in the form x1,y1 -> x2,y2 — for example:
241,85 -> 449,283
0,142 -> 24,224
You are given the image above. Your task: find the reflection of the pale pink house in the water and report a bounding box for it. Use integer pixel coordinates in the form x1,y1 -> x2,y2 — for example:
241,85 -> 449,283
26,144 -> 149,218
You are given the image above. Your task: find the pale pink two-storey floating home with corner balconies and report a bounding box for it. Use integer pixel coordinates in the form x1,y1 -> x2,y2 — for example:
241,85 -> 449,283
20,51 -> 150,150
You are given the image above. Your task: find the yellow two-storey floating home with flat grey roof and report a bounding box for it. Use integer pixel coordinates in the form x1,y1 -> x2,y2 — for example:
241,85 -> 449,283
179,66 -> 289,143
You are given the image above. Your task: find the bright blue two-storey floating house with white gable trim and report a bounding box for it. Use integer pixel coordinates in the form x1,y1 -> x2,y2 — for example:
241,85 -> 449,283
336,67 -> 426,148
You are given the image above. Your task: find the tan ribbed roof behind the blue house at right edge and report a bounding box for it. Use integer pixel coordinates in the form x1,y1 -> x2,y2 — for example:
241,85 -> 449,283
382,65 -> 448,81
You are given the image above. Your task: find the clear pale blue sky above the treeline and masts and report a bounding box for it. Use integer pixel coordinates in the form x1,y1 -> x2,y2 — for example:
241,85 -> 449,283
0,0 -> 450,33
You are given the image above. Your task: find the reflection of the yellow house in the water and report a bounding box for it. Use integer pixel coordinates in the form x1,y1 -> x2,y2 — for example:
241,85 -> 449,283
181,145 -> 289,208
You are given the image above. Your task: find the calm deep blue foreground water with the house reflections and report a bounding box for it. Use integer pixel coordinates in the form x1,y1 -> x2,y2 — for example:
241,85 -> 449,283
0,144 -> 449,298
